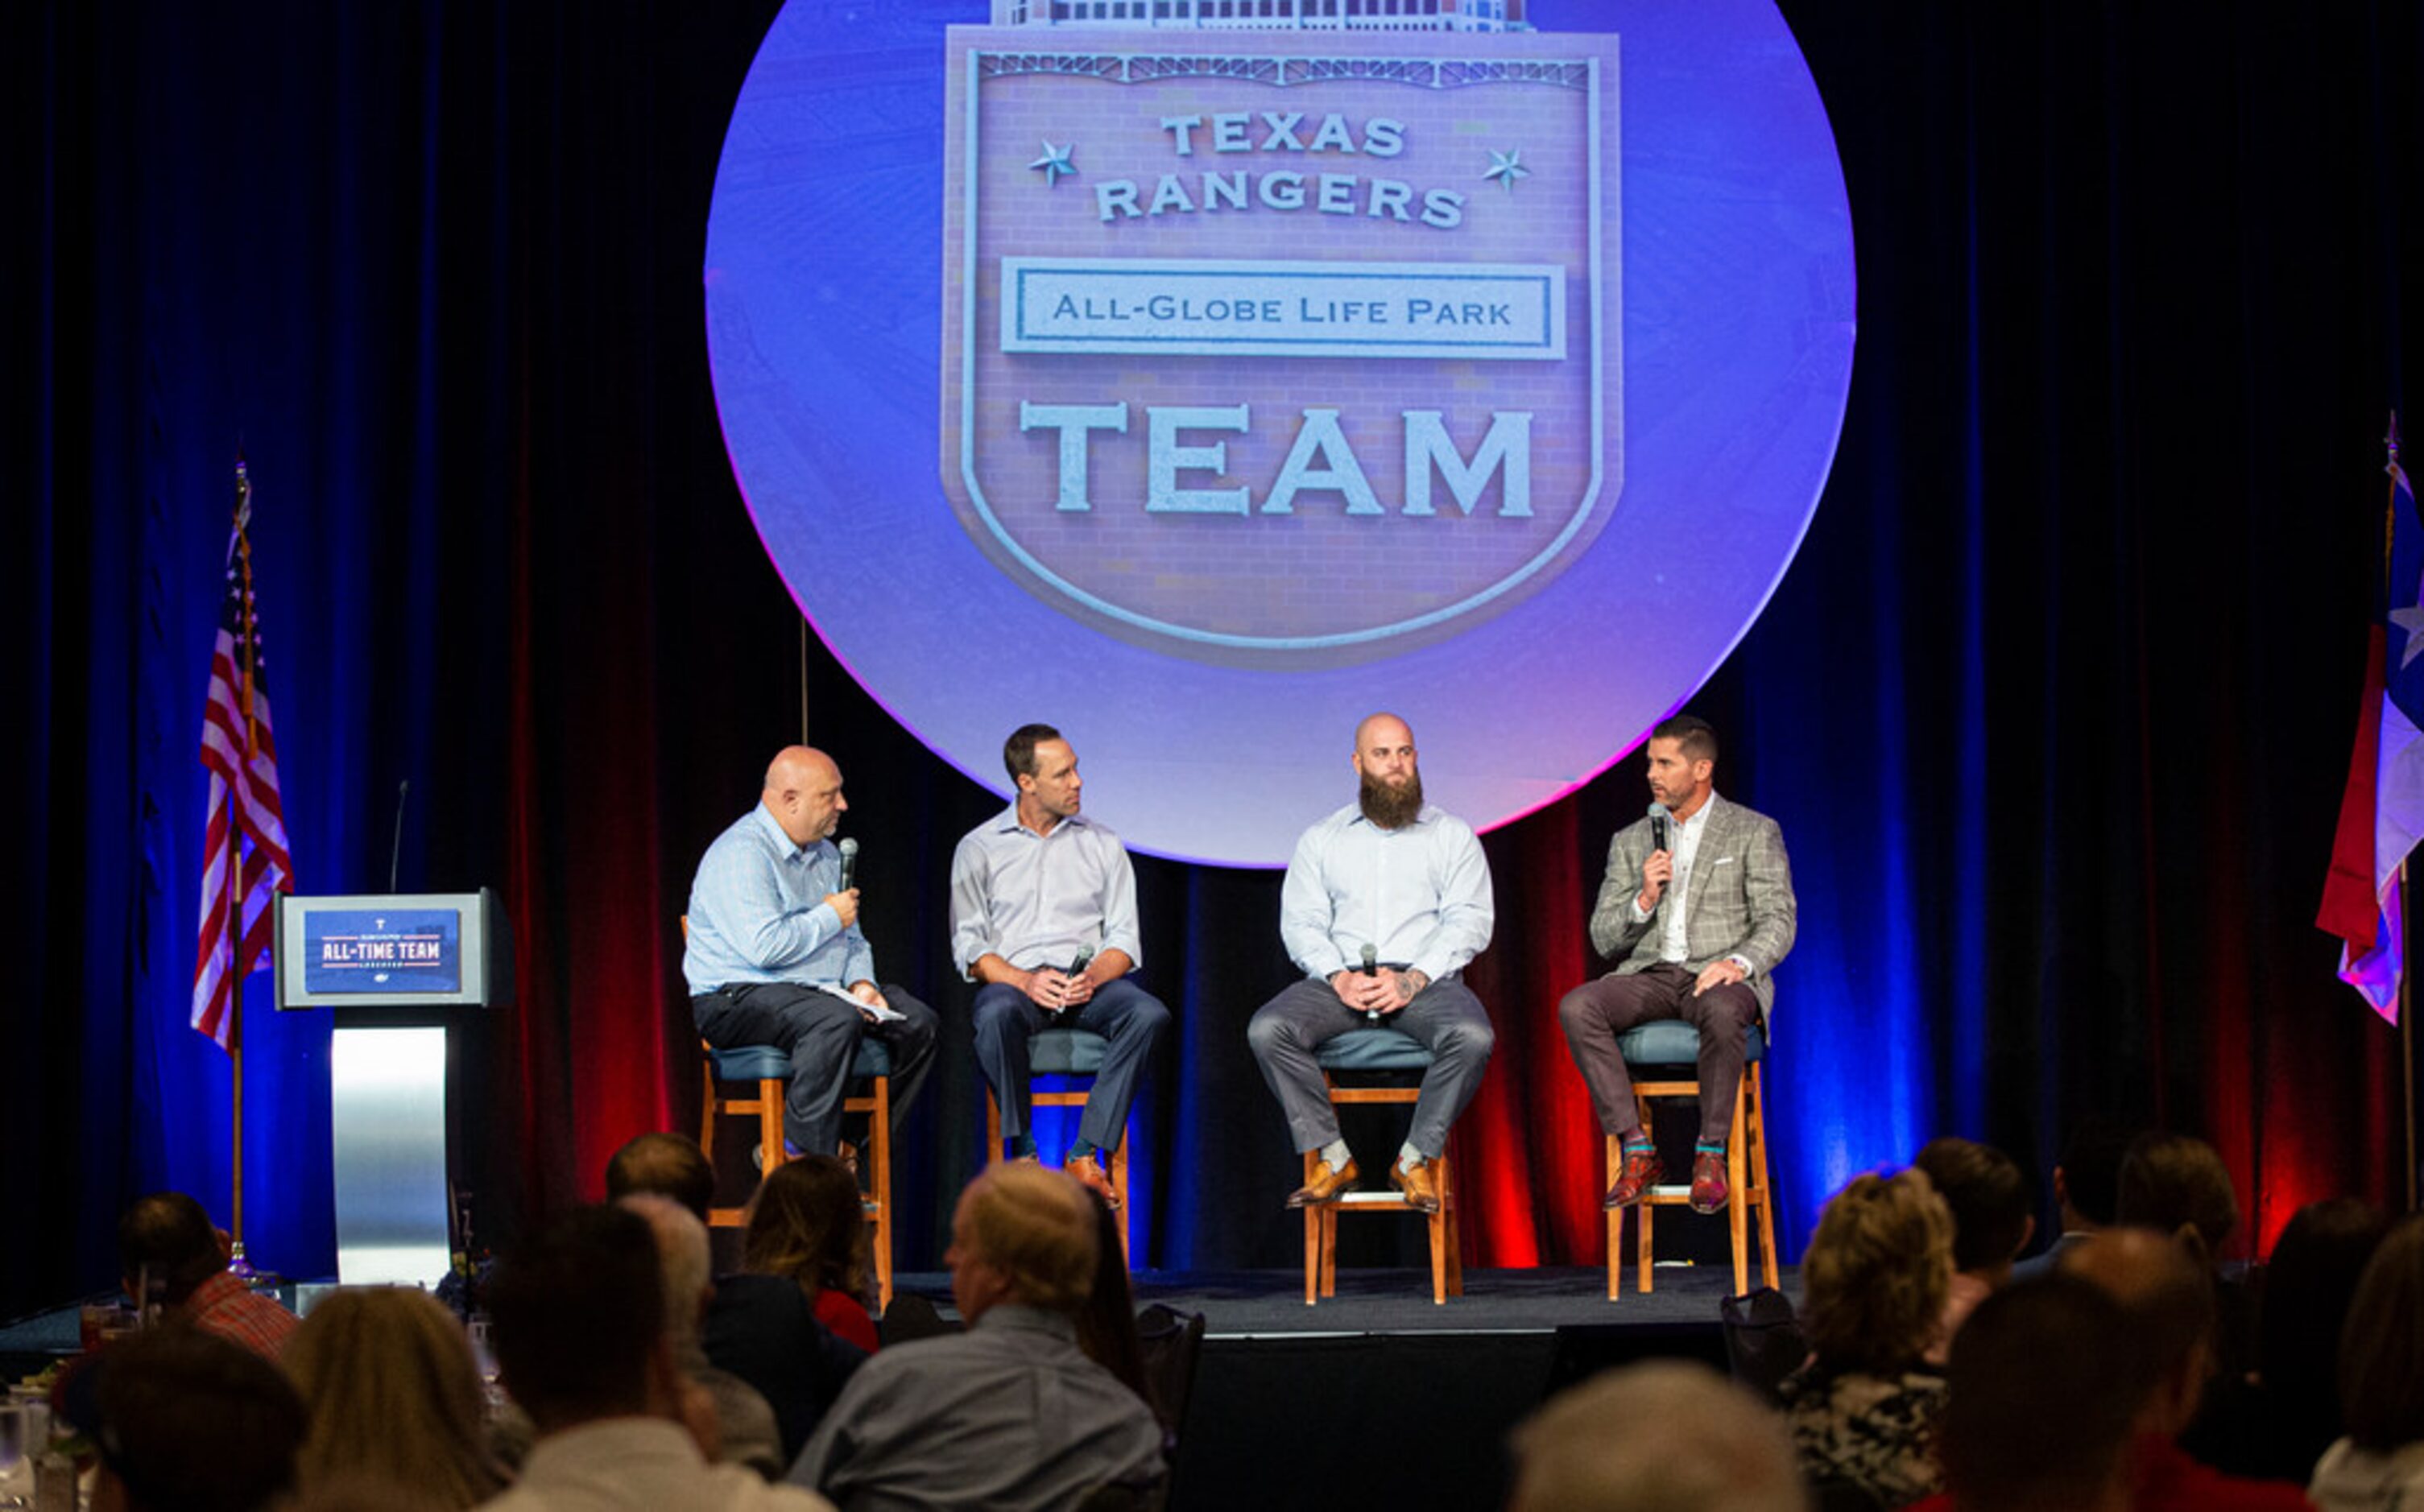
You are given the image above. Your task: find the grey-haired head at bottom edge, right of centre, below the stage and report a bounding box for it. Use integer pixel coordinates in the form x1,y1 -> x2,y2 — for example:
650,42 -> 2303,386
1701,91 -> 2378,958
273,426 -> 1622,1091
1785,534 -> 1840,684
1508,1359 -> 1808,1512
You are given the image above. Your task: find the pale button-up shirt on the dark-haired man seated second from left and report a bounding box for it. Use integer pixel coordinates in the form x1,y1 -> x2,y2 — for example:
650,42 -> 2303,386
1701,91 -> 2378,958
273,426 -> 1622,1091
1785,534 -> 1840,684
950,804 -> 1144,979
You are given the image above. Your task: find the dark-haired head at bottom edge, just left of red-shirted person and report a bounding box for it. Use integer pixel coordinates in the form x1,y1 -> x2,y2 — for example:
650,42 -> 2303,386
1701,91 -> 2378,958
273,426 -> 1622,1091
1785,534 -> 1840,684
1937,1274 -> 2143,1512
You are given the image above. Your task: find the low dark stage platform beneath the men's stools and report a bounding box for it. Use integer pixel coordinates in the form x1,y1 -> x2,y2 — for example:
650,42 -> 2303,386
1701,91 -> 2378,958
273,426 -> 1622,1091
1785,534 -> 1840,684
0,1265 -> 1801,1512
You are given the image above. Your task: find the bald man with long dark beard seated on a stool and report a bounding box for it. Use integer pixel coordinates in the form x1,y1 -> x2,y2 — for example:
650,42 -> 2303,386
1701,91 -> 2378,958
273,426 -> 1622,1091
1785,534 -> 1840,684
1246,715 -> 1495,1212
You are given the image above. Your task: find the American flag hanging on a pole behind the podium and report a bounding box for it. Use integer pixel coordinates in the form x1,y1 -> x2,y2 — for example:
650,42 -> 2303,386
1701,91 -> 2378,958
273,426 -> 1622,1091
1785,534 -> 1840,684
194,463 -> 293,1049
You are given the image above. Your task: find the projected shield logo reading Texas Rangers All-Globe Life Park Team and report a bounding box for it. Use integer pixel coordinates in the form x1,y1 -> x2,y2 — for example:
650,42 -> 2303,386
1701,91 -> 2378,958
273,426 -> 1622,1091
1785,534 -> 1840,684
941,20 -> 1624,669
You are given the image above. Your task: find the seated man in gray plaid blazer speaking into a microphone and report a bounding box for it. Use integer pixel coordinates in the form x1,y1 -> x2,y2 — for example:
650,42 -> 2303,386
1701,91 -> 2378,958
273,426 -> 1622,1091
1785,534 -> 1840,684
1556,715 -> 1793,1212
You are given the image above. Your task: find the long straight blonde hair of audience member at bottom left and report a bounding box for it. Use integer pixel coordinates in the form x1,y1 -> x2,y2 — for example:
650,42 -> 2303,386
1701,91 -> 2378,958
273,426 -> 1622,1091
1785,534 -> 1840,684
281,1287 -> 504,1507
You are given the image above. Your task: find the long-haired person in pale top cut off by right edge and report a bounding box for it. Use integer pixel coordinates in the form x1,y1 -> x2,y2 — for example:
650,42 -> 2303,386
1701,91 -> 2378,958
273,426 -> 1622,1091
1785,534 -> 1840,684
2306,1217 -> 2424,1512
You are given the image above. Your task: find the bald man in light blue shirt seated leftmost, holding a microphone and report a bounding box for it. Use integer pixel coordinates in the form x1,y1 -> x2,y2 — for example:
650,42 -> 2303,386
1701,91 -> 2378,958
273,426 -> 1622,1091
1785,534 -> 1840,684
681,746 -> 936,1156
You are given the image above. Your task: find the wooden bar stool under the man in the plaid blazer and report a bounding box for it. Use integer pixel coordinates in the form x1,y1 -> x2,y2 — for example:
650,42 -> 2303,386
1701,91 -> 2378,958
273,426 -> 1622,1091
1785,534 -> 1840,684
1607,1020 -> 1777,1301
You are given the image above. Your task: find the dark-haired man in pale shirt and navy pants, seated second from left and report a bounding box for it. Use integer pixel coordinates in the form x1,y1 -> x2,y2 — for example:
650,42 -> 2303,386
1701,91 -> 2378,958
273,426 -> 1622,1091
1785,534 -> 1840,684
950,725 -> 1171,1207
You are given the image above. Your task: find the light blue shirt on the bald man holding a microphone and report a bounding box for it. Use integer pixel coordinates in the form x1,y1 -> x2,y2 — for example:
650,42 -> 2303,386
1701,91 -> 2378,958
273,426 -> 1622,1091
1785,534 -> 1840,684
681,804 -> 875,996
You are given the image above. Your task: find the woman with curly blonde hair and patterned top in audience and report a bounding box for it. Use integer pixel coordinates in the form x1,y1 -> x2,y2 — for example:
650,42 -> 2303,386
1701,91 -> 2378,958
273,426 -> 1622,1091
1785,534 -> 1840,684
1781,1171 -> 1954,1507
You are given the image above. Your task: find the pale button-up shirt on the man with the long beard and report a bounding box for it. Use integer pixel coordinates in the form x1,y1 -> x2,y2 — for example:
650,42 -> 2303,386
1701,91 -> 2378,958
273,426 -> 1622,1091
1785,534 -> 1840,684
1280,804 -> 1498,981
